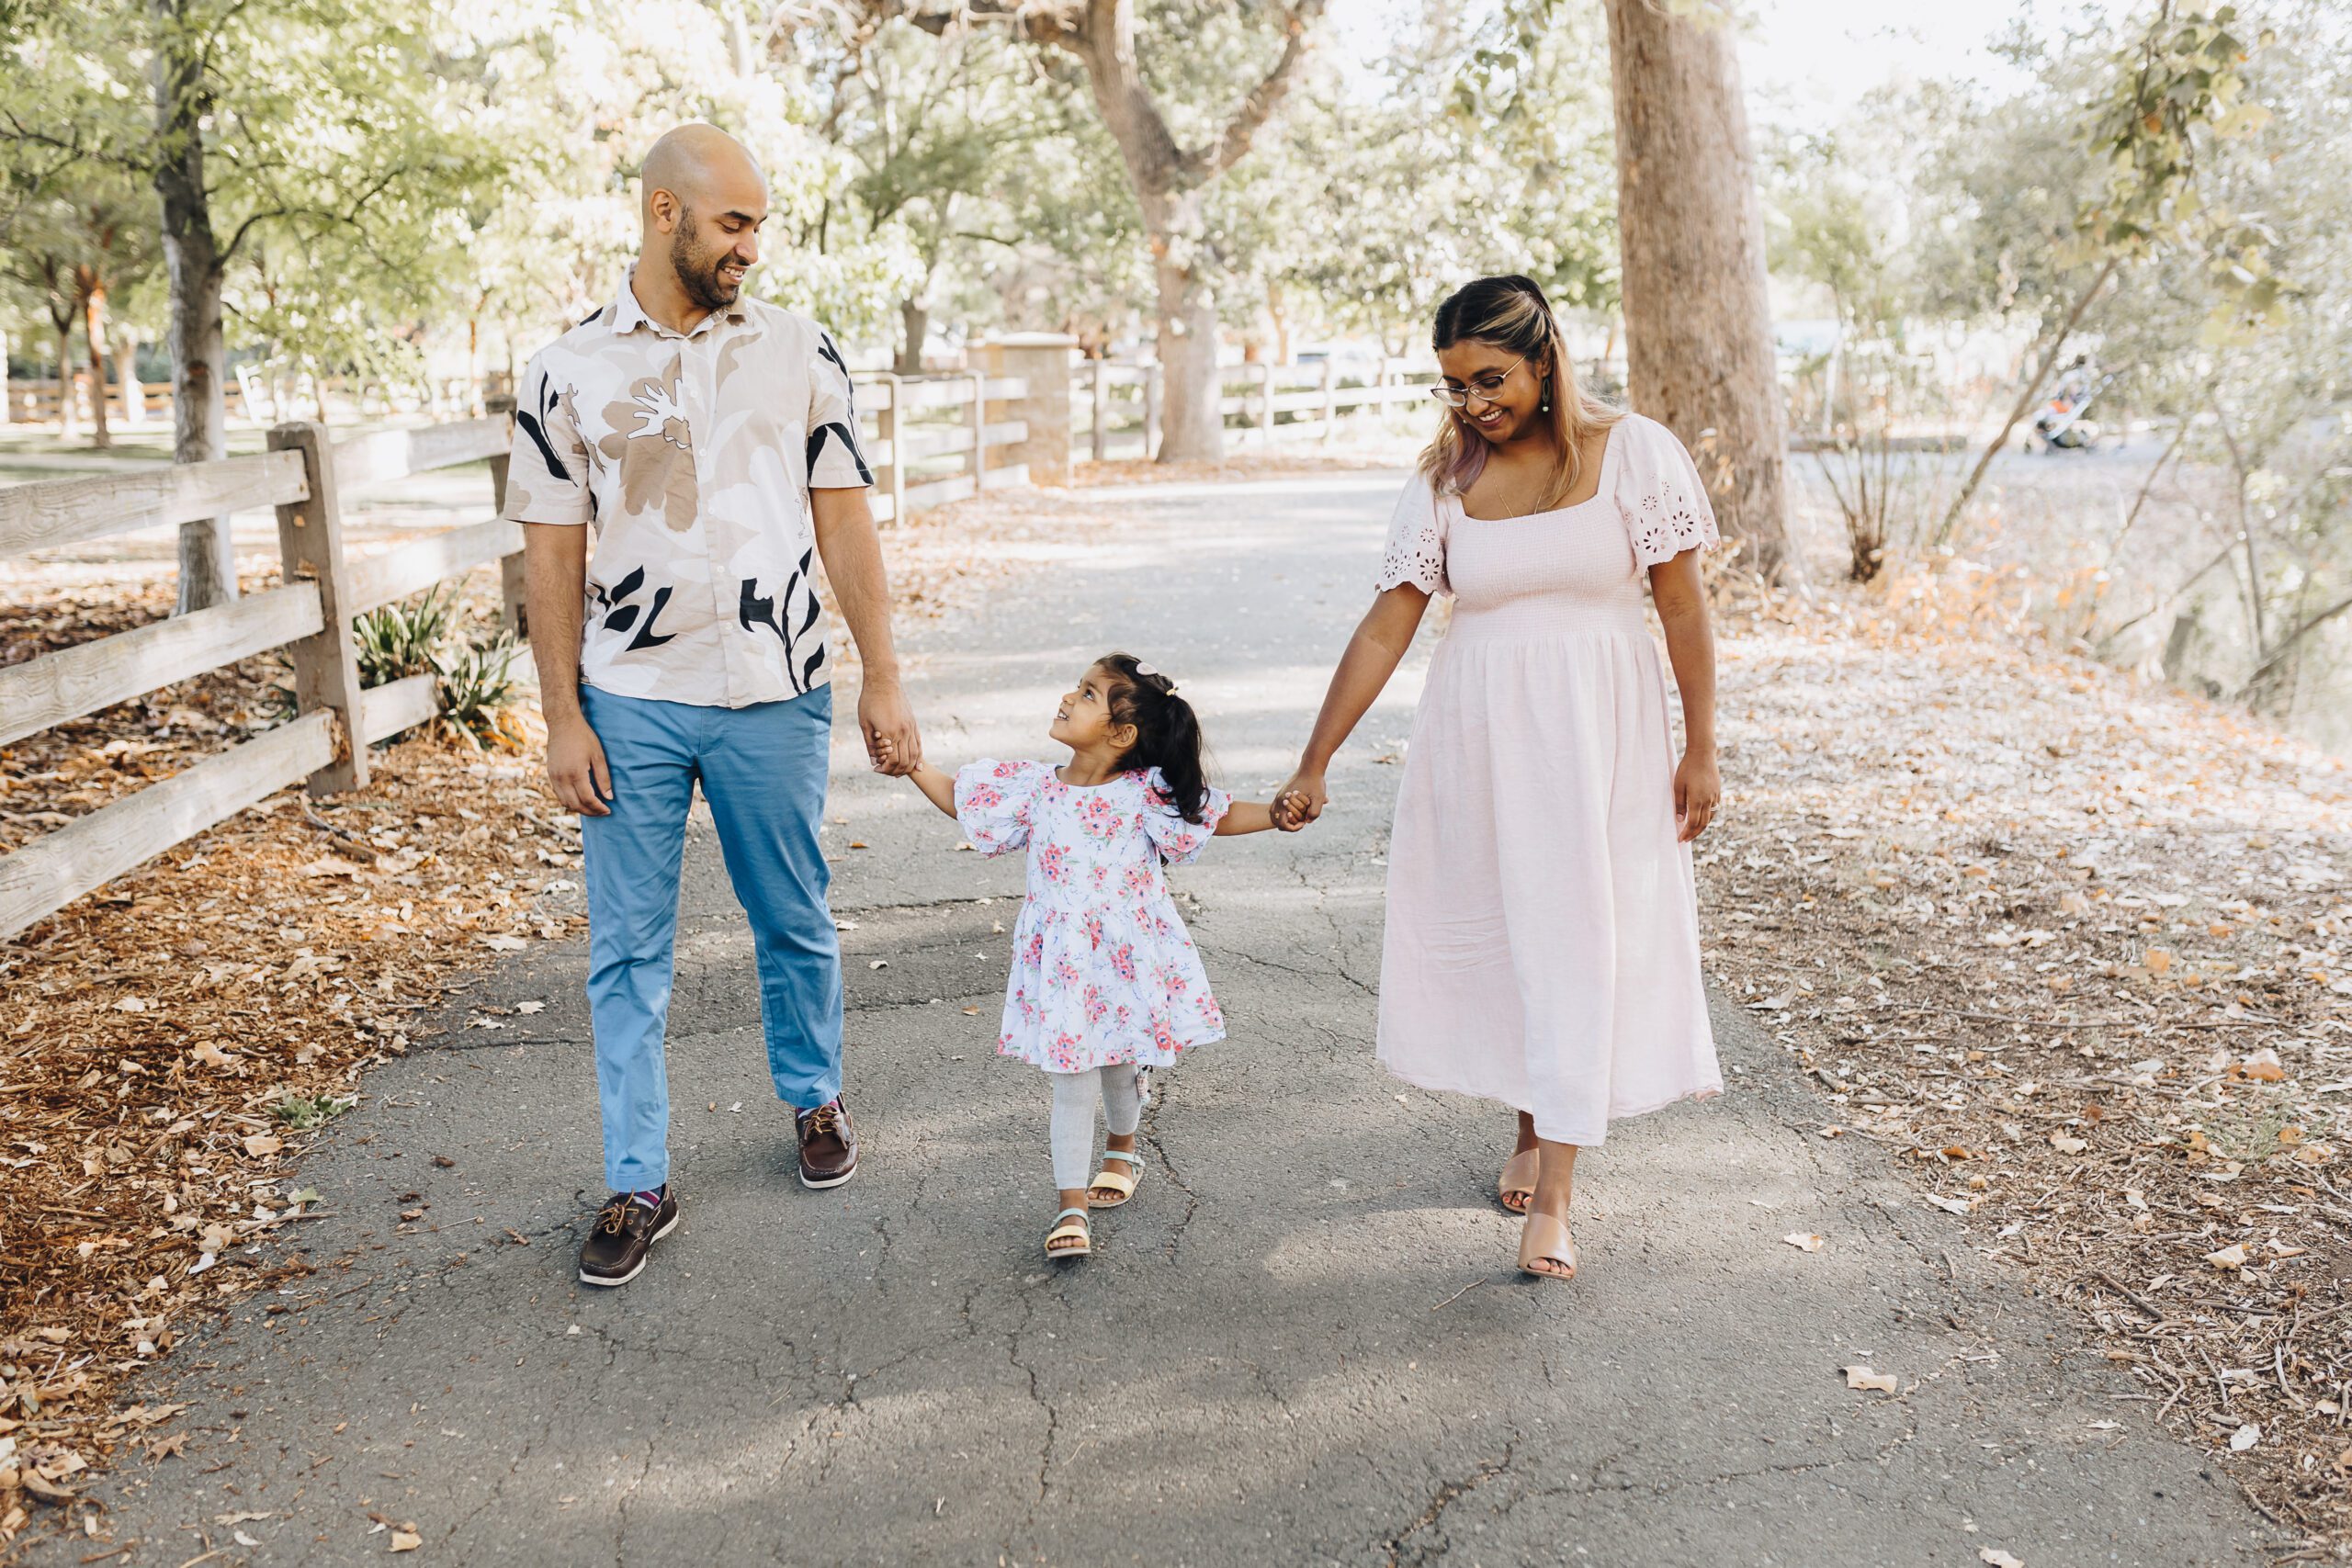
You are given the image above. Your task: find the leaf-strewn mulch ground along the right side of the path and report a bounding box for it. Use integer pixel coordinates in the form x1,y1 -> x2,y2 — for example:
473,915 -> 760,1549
1698,557 -> 2352,1559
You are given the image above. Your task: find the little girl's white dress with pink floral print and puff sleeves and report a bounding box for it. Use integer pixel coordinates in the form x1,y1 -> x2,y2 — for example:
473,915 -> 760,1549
955,761 -> 1232,1072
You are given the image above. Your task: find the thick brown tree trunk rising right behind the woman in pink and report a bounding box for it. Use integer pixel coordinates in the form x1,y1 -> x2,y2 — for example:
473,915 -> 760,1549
1609,0 -> 1790,579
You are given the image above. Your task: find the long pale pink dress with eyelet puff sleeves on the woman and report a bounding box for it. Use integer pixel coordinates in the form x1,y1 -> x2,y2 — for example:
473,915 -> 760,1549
1378,413 -> 1724,1147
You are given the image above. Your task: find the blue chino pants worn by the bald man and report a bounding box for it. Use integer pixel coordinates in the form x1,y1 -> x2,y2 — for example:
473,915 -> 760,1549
581,686 -> 842,1192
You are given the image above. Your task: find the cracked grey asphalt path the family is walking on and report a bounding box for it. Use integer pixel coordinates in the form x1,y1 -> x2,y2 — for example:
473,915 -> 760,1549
59,475 -> 2263,1568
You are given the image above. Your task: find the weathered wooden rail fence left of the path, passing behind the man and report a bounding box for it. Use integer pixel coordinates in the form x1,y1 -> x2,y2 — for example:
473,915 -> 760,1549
0,376 -> 1028,938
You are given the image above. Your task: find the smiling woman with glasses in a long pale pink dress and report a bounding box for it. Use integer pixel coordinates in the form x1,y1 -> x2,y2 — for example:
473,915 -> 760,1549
1284,277 -> 1722,1279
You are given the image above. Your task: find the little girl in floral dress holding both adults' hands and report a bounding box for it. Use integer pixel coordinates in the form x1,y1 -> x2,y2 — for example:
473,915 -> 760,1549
888,653 -> 1286,1258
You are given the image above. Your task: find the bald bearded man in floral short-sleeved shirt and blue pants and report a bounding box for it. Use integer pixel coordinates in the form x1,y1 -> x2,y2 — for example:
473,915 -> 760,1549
505,125 -> 922,1286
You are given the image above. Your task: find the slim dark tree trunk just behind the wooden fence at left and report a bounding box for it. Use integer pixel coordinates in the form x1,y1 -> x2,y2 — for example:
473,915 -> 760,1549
153,0 -> 238,614
